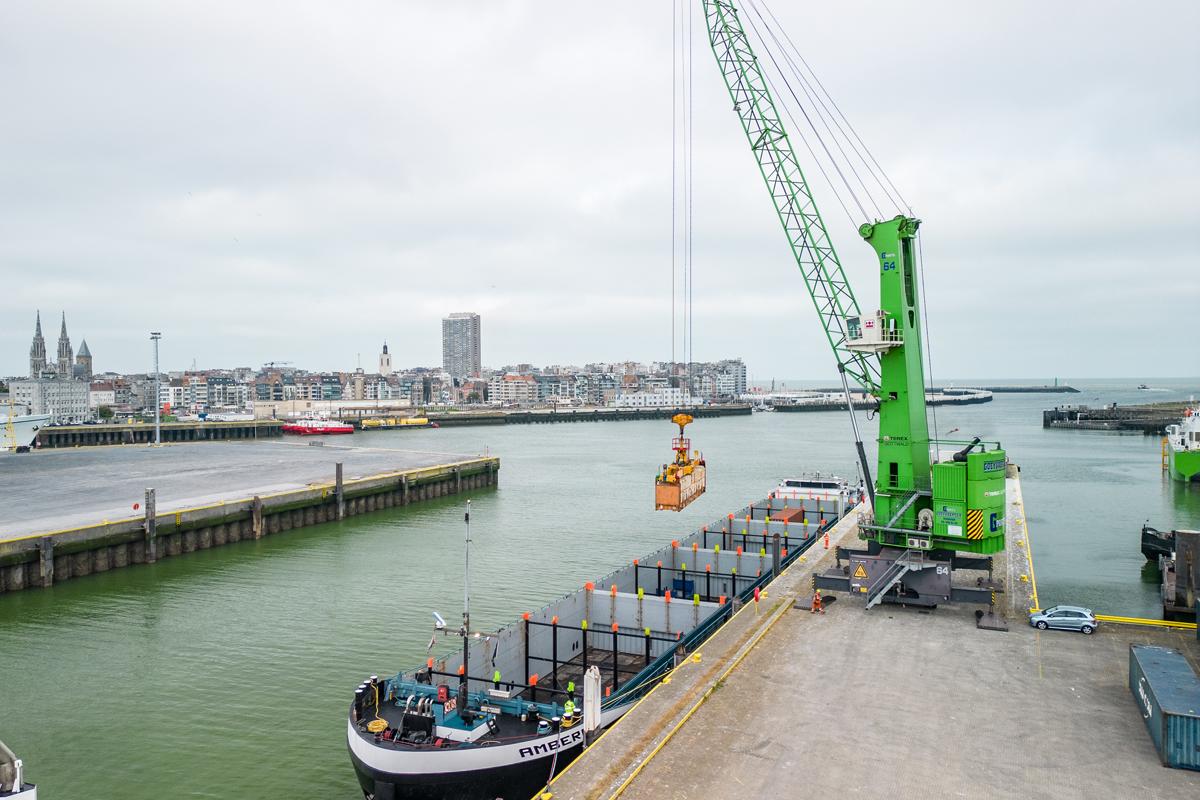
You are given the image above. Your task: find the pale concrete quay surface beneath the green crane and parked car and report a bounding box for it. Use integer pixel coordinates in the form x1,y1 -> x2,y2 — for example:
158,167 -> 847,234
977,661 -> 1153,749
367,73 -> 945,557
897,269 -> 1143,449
538,469 -> 1200,800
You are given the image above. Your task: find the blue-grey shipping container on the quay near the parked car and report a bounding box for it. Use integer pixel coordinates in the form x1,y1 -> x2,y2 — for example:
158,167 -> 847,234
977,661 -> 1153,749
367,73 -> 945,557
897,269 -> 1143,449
1129,644 -> 1200,770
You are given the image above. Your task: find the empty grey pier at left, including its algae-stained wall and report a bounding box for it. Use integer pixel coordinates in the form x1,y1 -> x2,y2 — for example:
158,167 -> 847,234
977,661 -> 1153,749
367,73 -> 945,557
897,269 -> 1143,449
0,443 -> 499,593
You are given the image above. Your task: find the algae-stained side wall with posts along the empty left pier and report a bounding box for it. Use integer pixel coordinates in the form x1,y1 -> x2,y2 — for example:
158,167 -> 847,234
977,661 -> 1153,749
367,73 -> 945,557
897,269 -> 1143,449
0,458 -> 500,593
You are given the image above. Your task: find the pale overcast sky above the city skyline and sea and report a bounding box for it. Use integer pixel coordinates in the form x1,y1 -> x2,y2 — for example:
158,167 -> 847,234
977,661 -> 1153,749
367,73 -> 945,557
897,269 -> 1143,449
0,0 -> 1200,379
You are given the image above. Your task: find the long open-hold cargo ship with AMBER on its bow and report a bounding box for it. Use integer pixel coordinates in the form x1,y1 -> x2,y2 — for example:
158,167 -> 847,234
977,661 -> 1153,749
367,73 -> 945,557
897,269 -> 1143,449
346,495 -> 848,800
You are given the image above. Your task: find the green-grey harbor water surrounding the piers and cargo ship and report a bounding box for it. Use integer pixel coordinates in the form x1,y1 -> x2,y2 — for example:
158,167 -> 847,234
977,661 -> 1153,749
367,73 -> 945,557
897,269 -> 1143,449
0,380 -> 1200,800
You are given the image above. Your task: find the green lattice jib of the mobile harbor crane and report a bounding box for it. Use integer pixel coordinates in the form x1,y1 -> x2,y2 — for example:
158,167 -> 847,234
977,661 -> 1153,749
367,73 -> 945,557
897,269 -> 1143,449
703,0 -> 880,393
